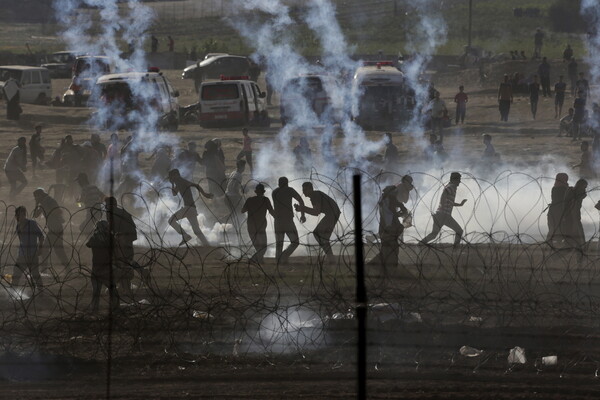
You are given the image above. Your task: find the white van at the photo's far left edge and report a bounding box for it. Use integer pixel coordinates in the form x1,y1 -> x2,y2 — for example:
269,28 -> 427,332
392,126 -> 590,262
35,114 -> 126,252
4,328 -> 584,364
0,65 -> 52,104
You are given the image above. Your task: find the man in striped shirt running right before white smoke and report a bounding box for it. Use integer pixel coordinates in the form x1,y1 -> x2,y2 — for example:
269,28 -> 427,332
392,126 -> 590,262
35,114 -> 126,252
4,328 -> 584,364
419,172 -> 467,247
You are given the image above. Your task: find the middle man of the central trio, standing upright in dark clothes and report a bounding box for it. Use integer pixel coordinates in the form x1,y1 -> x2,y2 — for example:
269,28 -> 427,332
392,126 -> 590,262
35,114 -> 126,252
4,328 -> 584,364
272,176 -> 306,264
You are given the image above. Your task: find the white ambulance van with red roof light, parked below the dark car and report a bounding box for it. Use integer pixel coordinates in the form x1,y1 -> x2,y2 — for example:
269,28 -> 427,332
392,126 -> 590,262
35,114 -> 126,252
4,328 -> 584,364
198,76 -> 271,126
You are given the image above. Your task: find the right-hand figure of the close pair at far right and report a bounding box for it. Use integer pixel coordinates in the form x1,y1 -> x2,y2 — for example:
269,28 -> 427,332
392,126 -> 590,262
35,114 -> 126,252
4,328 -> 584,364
561,179 -> 588,251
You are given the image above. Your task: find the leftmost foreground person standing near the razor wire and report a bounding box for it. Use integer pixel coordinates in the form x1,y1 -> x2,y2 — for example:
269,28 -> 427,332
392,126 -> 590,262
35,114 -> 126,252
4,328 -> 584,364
12,206 -> 44,287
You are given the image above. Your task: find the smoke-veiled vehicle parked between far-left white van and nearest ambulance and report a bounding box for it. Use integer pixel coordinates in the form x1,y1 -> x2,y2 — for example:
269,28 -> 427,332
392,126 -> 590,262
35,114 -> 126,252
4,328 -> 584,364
62,56 -> 114,107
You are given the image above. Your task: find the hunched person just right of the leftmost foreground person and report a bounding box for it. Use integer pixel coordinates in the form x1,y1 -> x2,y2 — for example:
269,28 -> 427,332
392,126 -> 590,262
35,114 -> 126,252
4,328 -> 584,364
33,188 -> 69,267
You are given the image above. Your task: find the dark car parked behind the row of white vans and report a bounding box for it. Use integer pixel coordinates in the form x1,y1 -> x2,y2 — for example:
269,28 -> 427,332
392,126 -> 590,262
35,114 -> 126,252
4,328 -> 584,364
181,54 -> 251,93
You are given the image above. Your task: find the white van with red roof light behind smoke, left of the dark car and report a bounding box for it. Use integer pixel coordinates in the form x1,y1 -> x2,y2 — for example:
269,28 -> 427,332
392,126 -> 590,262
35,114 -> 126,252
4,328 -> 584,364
92,68 -> 179,130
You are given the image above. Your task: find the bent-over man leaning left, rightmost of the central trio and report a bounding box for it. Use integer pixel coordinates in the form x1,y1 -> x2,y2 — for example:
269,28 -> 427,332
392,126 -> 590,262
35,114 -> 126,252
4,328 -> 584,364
294,182 -> 341,262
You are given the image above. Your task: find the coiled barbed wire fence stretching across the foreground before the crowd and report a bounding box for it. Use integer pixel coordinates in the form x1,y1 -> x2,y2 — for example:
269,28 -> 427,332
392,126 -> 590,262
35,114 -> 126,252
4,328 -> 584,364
0,169 -> 600,378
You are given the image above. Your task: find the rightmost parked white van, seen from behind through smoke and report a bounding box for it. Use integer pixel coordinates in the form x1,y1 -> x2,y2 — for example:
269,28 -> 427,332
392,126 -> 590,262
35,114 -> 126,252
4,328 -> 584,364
352,61 -> 415,129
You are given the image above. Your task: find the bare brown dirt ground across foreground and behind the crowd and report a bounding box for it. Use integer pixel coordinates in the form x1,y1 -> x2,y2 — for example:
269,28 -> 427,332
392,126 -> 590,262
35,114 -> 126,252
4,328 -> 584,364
0,62 -> 600,399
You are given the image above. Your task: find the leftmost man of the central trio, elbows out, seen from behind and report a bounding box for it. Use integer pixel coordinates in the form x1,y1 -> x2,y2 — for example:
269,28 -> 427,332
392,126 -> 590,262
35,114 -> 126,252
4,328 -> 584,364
242,183 -> 275,263
